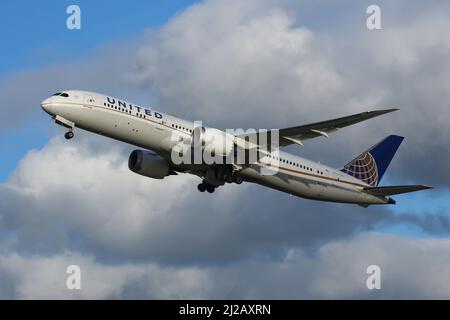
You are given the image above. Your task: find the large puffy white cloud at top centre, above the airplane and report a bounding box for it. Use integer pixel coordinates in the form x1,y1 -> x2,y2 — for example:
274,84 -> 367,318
131,1 -> 342,126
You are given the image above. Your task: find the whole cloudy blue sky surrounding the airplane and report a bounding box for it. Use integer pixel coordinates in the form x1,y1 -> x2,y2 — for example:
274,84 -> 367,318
0,0 -> 450,299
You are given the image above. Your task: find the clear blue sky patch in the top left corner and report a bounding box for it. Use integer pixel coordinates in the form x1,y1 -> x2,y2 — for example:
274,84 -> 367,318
0,0 -> 195,74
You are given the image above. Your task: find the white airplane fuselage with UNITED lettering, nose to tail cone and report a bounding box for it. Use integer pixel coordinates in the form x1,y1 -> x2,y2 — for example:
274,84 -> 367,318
42,91 -> 389,205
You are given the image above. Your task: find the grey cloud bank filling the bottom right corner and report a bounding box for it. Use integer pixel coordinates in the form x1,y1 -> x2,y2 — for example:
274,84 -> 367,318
213,233 -> 450,299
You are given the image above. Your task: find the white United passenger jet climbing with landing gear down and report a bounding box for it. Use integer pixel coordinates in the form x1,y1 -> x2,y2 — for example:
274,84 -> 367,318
41,90 -> 432,208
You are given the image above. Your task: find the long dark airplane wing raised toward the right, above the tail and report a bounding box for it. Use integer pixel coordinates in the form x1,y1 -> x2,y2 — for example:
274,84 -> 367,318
237,109 -> 399,147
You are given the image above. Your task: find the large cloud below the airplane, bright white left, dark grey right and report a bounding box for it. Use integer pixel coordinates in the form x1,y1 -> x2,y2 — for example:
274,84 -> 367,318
0,134 -> 398,264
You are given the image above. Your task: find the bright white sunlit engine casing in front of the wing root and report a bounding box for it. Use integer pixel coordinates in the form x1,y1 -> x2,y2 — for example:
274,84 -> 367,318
191,127 -> 234,157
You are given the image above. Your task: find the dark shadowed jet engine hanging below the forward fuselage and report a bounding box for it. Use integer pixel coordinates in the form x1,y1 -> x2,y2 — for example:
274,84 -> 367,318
128,150 -> 171,179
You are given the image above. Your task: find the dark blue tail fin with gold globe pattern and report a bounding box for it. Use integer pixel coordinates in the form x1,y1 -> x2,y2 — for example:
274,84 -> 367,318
341,135 -> 404,187
